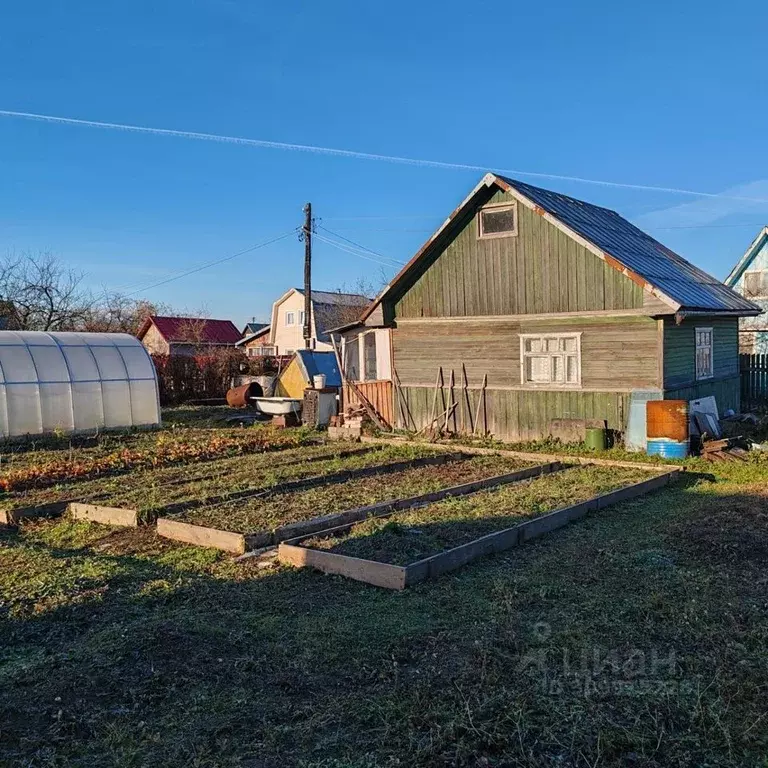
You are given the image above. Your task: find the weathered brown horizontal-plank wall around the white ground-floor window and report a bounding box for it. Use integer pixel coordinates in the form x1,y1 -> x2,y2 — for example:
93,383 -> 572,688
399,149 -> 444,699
392,316 -> 661,391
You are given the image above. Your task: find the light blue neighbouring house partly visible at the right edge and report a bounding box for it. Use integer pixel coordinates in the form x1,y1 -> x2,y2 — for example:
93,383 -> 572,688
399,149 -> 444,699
725,227 -> 768,355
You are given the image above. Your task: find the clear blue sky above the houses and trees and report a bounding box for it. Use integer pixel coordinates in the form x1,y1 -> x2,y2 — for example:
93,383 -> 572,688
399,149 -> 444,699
0,0 -> 768,324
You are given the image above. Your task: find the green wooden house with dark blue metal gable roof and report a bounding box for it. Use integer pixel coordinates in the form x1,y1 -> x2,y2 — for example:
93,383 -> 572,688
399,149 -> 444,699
344,174 -> 760,439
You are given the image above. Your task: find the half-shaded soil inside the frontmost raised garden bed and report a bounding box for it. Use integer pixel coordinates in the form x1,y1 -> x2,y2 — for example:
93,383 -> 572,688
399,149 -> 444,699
303,466 -> 649,565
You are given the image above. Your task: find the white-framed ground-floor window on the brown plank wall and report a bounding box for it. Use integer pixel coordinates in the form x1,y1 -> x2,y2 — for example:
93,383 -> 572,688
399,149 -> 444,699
520,333 -> 581,388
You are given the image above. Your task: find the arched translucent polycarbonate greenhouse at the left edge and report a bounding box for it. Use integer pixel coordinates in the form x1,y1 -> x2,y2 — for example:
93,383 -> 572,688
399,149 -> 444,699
0,331 -> 160,437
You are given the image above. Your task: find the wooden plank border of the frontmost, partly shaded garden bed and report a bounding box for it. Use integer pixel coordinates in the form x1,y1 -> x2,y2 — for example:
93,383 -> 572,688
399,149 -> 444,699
278,467 -> 681,590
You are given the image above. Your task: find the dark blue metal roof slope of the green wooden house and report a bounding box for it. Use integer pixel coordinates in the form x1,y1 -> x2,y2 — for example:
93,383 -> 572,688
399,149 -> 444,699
497,176 -> 760,314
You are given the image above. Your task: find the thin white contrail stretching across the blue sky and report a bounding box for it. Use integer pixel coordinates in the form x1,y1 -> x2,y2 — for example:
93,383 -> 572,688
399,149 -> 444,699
0,109 -> 768,203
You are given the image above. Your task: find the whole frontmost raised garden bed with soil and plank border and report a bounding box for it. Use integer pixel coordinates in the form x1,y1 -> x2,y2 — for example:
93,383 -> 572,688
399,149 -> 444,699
279,466 -> 678,589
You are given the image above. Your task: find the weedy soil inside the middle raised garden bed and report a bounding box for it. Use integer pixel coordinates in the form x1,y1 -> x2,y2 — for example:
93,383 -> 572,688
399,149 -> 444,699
174,456 -> 531,534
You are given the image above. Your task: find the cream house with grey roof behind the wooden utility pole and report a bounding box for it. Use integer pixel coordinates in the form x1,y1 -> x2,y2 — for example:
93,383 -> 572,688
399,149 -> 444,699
269,288 -> 371,355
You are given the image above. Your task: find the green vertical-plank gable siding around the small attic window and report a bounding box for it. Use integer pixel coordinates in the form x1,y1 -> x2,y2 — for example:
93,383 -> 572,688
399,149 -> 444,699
388,191 -> 644,317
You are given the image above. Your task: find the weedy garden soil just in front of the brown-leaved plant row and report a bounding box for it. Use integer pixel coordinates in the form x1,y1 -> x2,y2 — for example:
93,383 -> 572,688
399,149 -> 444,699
3,443 -> 447,511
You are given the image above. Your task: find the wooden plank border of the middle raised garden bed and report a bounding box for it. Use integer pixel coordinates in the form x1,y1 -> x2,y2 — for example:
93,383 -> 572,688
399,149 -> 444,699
157,461 -> 564,555
